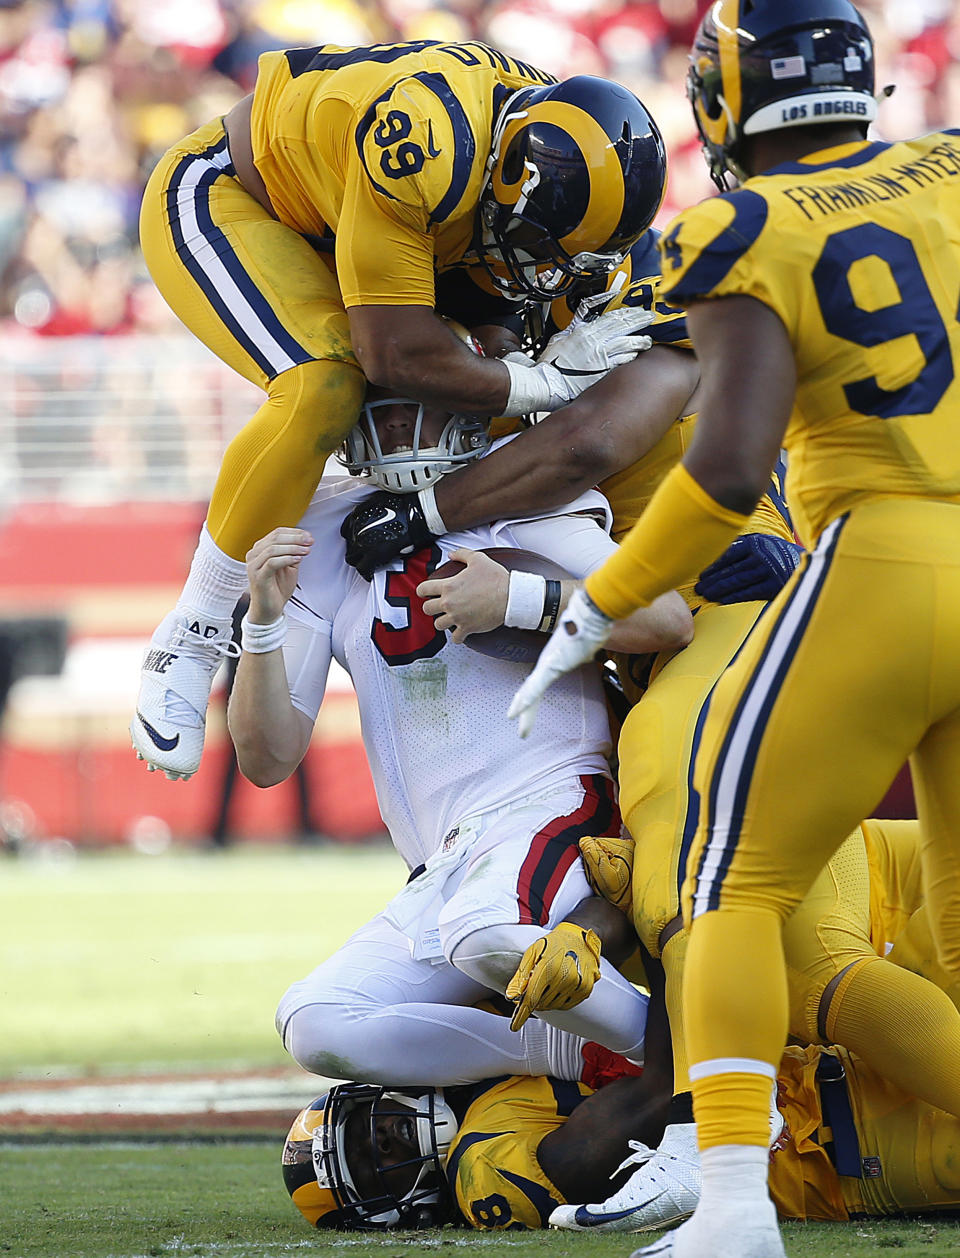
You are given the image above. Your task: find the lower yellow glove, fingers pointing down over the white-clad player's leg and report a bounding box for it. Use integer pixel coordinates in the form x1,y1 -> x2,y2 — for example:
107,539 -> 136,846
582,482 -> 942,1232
506,922 -> 600,1030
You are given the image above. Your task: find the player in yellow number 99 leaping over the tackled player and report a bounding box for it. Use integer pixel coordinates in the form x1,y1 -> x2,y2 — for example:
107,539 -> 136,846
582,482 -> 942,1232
131,40 -> 666,777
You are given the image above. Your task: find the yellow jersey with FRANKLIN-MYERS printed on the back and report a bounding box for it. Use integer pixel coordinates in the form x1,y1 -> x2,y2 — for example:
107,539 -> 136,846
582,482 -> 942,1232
661,131 -> 960,546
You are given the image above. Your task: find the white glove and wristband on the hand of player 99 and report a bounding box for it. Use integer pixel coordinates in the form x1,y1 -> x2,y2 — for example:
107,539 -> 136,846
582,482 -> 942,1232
501,306 -> 654,415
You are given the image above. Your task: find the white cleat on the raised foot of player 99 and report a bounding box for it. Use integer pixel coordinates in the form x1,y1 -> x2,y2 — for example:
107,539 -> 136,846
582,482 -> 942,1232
130,608 -> 240,781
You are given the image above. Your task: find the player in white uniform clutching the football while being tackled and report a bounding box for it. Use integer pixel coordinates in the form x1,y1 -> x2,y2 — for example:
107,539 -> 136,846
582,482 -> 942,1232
229,362 -> 692,1084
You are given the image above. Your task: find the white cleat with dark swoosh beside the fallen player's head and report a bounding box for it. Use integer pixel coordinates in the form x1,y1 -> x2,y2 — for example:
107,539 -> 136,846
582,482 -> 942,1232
550,1122 -> 701,1232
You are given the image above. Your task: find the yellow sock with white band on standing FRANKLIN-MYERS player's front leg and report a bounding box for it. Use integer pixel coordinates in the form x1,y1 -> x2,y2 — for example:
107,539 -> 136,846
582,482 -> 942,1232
683,908 -> 788,1149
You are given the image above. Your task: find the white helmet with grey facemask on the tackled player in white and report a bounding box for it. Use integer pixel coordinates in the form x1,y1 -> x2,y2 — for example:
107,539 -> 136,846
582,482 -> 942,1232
336,320 -> 491,493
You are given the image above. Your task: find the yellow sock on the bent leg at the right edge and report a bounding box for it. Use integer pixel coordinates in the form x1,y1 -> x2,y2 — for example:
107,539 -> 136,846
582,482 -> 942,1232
827,957 -> 960,1117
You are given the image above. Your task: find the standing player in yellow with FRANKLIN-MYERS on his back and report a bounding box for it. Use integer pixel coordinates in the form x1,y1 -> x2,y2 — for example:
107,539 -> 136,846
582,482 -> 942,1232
513,0 -> 960,1258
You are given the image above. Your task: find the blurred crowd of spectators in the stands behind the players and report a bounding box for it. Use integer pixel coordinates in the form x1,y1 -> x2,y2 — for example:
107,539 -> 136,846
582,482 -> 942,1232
0,0 -> 960,336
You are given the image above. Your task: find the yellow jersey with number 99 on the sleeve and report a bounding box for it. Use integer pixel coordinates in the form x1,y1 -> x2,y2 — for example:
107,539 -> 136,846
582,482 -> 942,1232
250,40 -> 556,307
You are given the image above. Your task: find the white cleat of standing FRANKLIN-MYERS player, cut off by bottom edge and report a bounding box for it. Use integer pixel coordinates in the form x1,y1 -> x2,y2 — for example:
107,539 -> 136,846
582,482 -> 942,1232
630,1199 -> 786,1258
